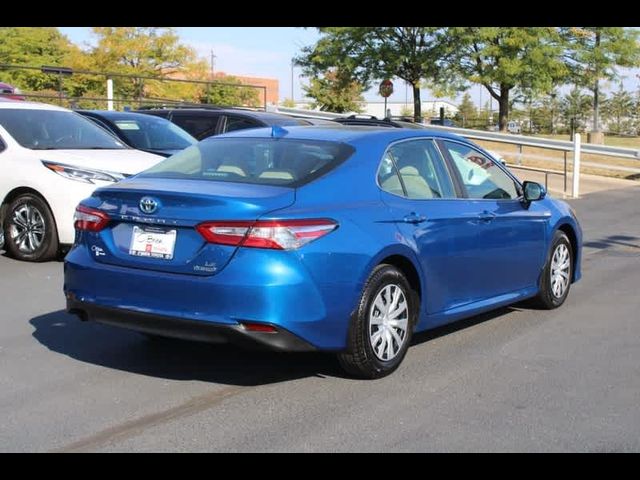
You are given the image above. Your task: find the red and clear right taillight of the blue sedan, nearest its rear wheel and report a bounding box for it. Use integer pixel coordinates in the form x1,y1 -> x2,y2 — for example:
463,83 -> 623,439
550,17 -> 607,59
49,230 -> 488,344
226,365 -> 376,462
196,218 -> 338,250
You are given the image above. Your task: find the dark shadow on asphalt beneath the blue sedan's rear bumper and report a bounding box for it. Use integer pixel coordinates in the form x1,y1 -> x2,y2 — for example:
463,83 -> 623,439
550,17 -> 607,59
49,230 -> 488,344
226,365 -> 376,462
29,310 -> 346,386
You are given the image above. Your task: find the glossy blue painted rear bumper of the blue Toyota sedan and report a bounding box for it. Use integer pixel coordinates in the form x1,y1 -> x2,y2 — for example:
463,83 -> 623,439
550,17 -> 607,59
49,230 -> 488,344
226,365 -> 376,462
64,244 -> 364,351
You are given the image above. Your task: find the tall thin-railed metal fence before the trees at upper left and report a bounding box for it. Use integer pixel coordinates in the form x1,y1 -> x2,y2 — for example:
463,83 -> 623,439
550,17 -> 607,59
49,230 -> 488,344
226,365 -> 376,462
0,64 -> 267,110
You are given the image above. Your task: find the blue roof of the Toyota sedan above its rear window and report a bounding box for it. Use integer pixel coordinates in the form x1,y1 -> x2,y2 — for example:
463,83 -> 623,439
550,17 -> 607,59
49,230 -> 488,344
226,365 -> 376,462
214,125 -> 464,143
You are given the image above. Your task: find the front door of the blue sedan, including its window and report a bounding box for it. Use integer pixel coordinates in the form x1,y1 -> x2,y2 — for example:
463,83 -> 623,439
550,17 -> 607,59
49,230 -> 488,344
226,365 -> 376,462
440,140 -> 551,299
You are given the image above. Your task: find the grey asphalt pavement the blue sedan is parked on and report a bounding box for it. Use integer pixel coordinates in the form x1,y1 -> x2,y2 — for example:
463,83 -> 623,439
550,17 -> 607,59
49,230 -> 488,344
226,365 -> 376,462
0,187 -> 640,451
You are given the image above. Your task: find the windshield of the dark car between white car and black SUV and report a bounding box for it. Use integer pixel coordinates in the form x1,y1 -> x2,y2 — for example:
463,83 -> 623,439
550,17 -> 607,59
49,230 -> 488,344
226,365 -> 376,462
113,115 -> 197,150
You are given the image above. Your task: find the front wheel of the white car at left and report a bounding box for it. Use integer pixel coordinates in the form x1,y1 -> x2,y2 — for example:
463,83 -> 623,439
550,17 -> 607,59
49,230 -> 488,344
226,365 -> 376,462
3,193 -> 59,262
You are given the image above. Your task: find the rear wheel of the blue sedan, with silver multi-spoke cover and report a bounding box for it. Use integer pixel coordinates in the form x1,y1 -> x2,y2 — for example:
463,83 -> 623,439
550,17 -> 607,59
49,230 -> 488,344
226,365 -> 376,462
338,265 -> 418,378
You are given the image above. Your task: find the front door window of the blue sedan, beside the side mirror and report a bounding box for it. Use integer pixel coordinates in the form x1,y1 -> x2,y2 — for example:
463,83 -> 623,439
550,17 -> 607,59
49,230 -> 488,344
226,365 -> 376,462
443,141 -> 519,200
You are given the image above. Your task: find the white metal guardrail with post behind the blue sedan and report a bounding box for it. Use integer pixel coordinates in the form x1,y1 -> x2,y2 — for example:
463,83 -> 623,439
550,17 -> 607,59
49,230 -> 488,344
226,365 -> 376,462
267,107 -> 640,198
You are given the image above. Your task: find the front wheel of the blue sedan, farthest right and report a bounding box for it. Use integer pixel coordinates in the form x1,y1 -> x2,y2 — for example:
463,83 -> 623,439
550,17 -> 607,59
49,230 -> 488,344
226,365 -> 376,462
536,230 -> 573,309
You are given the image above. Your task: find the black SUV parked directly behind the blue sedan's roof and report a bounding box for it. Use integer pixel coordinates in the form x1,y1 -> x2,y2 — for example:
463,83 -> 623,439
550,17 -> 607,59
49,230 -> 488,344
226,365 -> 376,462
137,106 -> 311,140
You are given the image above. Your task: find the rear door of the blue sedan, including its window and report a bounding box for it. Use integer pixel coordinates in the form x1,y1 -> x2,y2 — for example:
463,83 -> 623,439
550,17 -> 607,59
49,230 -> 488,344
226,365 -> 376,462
378,138 -> 482,315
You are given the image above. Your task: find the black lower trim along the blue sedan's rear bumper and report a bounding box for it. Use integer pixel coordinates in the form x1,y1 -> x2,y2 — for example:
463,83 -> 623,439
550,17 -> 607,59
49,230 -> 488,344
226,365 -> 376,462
67,298 -> 316,352
